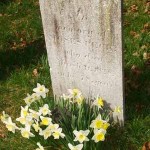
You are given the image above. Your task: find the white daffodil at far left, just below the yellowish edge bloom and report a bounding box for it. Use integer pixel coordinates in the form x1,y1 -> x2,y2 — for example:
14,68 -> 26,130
4,117 -> 19,133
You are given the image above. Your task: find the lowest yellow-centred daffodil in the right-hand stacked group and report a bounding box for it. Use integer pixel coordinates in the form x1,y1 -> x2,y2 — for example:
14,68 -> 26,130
92,129 -> 106,143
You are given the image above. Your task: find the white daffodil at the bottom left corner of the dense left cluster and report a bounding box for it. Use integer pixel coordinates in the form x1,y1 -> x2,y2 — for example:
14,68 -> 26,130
20,125 -> 35,139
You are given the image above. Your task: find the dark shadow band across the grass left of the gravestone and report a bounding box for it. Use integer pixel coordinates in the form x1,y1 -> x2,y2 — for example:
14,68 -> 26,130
0,39 -> 46,81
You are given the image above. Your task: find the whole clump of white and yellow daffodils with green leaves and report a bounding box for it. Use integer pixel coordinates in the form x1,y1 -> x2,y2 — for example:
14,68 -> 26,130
1,83 -> 121,150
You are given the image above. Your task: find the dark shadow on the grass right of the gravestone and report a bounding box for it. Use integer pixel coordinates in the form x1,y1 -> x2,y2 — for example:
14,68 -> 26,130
125,62 -> 150,120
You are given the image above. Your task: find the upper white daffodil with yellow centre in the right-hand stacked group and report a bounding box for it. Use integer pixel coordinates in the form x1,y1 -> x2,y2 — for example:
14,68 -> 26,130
90,114 -> 103,129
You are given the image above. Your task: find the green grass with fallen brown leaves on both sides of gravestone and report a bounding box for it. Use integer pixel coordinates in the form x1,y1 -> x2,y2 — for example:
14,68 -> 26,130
0,0 -> 150,150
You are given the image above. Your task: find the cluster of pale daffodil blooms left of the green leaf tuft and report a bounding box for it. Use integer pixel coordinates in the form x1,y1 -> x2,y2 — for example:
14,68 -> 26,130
1,83 -> 65,150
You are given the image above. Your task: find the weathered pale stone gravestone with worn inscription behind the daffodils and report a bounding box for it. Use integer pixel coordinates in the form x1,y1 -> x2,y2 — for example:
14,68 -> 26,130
40,0 -> 124,120
